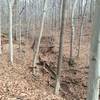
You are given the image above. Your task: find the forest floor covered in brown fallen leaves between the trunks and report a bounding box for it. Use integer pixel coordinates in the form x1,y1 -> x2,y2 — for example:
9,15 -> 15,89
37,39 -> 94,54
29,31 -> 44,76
0,21 -> 91,100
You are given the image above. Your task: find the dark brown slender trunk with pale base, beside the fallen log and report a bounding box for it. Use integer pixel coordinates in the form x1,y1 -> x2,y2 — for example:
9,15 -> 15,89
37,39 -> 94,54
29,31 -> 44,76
55,0 -> 66,95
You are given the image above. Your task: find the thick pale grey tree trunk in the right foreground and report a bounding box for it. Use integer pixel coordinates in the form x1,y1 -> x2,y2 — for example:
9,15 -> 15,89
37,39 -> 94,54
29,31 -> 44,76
87,0 -> 100,100
